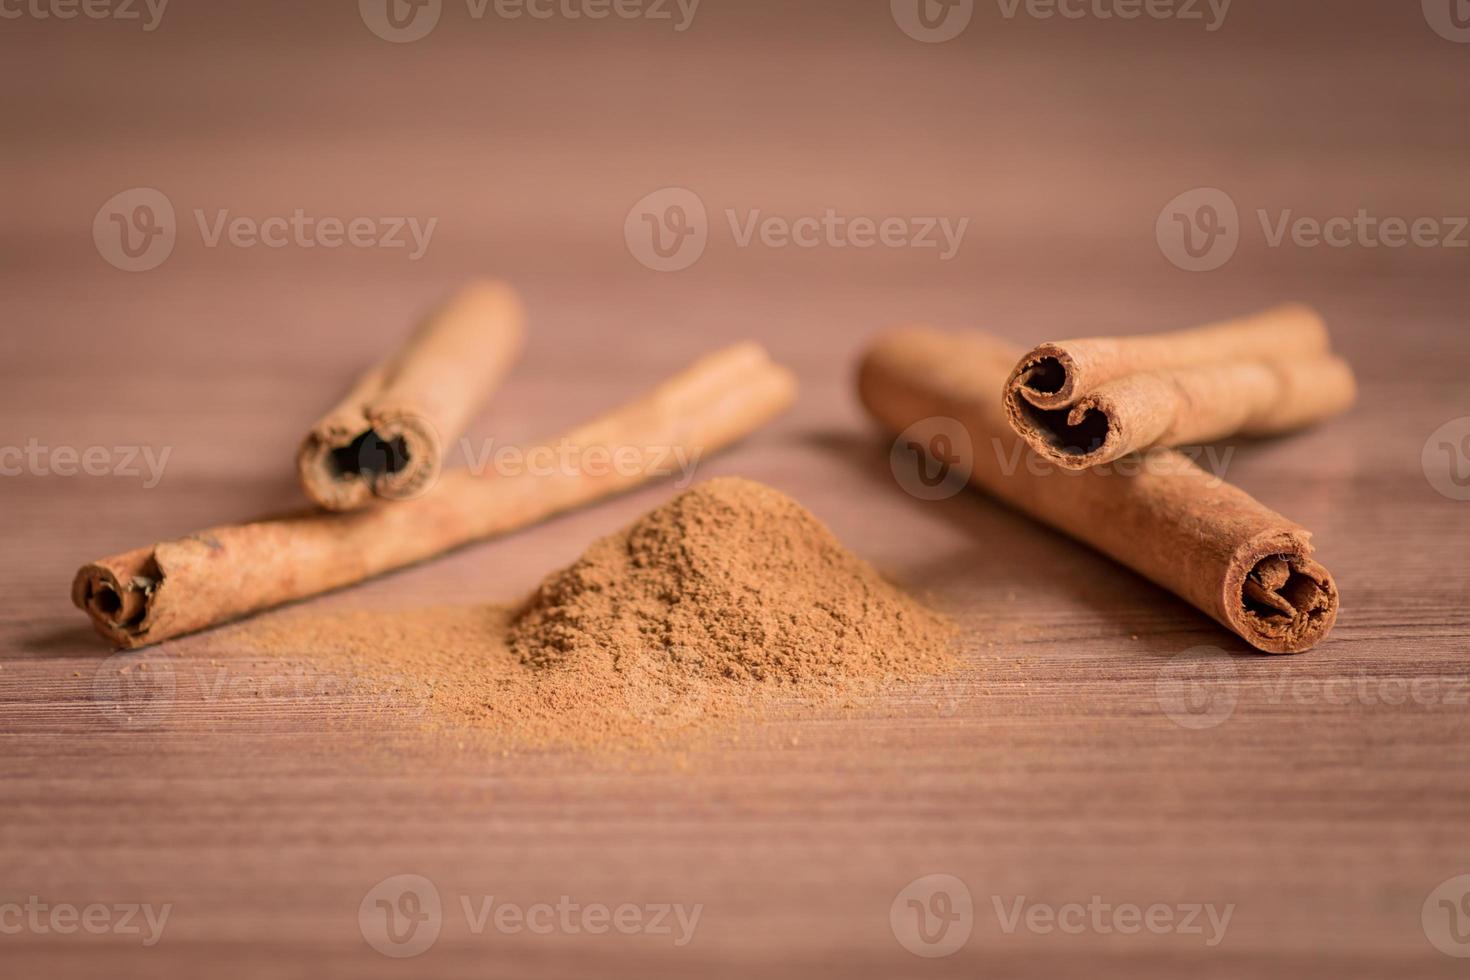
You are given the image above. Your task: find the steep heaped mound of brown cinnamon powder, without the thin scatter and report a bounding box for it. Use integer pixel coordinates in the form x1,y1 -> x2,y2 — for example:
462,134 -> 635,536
509,479 -> 950,688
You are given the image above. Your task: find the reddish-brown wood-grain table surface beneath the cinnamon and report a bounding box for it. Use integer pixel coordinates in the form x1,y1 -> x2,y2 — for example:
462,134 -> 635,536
0,0 -> 1470,979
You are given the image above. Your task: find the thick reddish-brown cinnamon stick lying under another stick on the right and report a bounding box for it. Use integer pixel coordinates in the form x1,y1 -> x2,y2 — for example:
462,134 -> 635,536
858,328 -> 1338,654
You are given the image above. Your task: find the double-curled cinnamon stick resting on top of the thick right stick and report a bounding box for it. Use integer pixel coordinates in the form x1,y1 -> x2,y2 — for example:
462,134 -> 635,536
1003,304 -> 1357,470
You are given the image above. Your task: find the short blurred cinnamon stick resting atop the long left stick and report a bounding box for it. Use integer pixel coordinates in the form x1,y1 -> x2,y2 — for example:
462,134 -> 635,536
297,281 -> 525,510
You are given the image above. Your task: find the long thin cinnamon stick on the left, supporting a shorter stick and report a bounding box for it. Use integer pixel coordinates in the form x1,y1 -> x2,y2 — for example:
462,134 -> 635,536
72,344 -> 795,648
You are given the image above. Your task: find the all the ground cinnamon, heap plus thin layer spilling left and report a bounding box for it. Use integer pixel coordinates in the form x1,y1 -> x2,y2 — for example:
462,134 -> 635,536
232,479 -> 954,746
